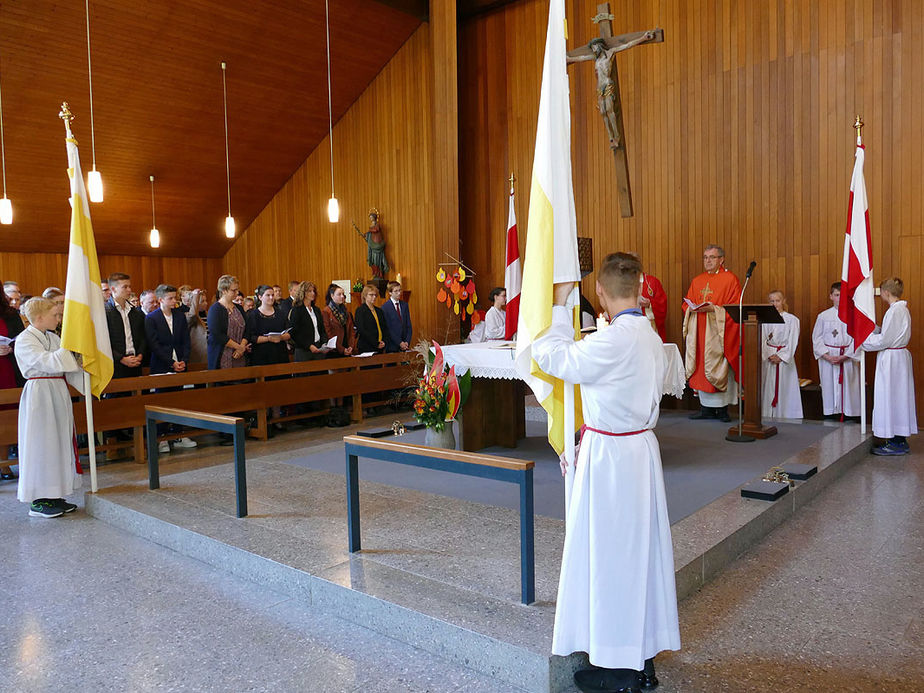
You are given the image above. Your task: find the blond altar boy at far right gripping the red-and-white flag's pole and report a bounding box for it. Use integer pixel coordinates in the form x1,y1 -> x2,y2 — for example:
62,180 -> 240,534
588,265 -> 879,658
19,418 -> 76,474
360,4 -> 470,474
863,277 -> 918,455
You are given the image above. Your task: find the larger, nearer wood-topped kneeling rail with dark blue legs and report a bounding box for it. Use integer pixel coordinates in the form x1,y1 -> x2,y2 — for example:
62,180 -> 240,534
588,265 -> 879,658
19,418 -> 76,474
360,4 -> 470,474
343,435 -> 536,604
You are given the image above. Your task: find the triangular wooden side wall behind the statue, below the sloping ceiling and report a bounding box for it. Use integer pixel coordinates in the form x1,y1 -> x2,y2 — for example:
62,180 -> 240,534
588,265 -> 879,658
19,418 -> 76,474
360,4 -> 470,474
223,24 -> 452,340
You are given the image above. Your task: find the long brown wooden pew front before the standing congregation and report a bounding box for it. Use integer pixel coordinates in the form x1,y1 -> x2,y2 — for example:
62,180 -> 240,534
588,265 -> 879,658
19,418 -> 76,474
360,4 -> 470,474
0,352 -> 417,463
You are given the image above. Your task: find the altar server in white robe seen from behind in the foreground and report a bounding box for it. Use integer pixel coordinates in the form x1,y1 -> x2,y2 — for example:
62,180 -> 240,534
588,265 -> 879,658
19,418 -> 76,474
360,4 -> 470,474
533,253 -> 680,691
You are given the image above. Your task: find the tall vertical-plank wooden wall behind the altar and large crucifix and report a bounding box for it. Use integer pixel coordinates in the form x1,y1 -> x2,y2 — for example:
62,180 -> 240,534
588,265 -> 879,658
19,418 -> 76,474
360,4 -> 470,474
459,0 -> 924,424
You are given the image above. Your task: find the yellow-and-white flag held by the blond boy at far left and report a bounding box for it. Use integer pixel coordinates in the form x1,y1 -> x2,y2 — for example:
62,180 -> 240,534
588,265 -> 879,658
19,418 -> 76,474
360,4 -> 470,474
61,137 -> 112,398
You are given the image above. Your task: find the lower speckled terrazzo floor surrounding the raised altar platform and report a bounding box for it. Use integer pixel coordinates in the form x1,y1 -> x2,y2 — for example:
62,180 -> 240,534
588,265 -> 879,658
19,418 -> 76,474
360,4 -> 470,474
0,410 -> 924,693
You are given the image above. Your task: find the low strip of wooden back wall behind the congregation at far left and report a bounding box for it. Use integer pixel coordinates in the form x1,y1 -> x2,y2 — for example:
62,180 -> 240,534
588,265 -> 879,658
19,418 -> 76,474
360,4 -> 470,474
0,252 -> 221,296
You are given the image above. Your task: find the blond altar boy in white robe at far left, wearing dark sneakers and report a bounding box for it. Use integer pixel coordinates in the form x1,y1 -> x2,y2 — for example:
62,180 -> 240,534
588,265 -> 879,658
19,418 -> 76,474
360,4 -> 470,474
15,297 -> 83,517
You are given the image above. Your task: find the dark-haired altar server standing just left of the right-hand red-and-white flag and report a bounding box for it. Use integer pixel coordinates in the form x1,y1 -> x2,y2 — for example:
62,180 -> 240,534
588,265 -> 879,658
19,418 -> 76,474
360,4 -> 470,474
812,282 -> 862,421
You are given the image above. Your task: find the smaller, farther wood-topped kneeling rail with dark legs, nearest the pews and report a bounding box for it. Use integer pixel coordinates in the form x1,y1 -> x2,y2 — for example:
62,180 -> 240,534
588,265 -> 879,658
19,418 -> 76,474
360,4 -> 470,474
144,405 -> 247,517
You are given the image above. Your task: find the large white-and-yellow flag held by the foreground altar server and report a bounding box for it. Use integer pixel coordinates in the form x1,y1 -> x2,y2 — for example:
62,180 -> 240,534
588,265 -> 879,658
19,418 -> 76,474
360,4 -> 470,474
516,0 -> 581,454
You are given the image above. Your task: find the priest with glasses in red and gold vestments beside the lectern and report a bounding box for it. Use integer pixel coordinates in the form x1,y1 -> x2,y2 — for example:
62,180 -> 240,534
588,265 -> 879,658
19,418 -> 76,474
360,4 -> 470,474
683,245 -> 741,421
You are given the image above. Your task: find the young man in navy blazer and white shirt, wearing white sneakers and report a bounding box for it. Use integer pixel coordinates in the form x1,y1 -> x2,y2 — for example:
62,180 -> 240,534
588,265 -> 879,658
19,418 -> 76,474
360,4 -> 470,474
144,284 -> 196,452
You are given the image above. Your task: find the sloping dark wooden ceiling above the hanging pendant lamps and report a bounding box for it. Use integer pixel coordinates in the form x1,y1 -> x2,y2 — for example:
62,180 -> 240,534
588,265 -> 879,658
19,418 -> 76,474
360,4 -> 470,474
0,0 -> 420,257
